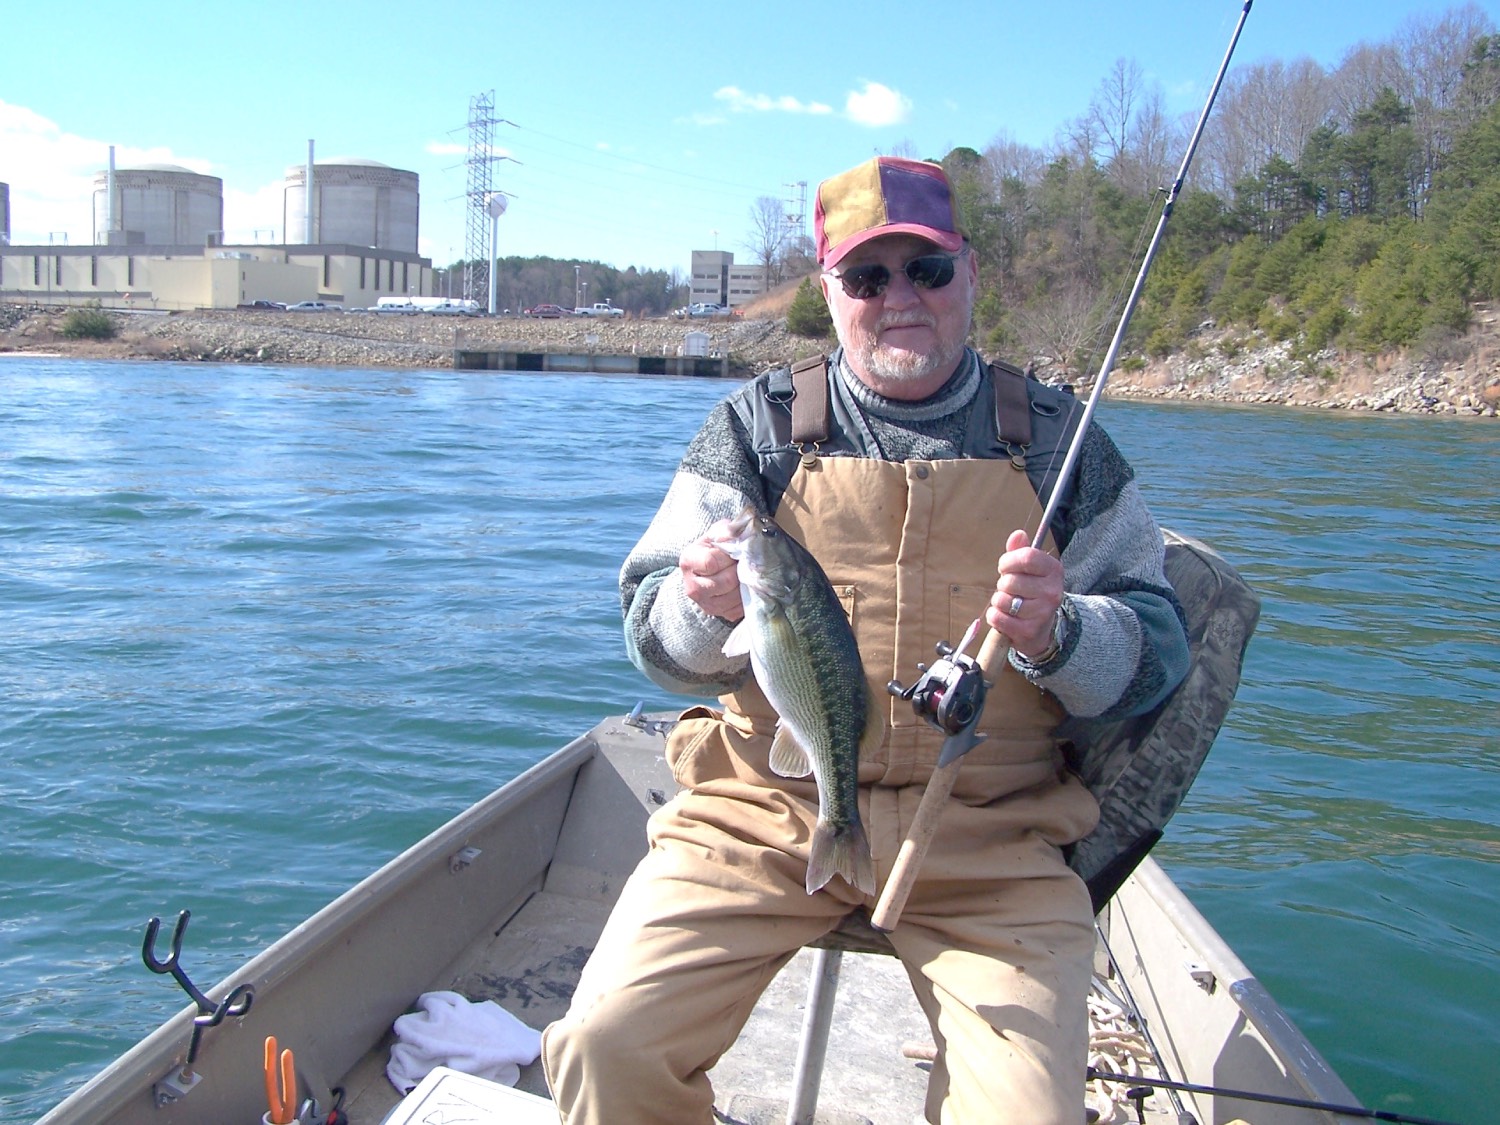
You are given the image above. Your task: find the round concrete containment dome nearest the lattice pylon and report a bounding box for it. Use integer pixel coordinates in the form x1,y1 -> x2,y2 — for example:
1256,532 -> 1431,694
284,156 -> 417,254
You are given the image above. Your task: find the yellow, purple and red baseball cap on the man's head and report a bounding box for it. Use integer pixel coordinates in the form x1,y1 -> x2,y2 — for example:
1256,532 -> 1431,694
813,156 -> 969,270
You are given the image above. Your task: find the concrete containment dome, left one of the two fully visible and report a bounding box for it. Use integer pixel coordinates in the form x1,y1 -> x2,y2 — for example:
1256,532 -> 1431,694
93,164 -> 224,246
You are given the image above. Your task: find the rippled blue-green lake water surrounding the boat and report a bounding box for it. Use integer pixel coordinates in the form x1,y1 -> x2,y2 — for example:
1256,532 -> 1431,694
0,357 -> 1500,1124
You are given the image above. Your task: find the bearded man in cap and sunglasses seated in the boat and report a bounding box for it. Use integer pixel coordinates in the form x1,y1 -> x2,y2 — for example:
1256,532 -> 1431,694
543,158 -> 1187,1125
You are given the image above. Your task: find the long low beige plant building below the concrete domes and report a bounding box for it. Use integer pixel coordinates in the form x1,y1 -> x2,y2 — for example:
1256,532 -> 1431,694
0,243 -> 432,311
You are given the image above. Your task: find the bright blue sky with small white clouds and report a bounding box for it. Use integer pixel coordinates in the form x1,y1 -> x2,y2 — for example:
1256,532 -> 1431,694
0,0 -> 1500,275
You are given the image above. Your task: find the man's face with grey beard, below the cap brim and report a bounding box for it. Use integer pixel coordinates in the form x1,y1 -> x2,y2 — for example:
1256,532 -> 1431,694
821,234 -> 978,402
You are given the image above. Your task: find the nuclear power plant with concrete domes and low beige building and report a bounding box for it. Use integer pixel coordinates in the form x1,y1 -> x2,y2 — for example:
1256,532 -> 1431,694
0,143 -> 432,311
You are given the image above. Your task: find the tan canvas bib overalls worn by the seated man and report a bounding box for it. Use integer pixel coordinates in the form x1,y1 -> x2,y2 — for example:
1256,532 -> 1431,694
543,458 -> 1098,1125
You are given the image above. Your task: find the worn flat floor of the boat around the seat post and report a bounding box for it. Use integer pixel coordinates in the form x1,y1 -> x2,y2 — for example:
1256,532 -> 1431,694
334,893 -> 1167,1125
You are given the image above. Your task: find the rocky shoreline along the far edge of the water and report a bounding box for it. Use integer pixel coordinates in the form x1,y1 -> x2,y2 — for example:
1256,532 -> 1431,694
0,305 -> 1500,417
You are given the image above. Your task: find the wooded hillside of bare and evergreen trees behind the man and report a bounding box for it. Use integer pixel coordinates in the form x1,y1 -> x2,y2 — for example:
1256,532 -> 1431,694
942,5 -> 1500,381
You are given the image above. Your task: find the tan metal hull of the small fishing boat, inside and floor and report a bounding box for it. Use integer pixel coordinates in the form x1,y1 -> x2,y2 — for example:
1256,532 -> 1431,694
41,717 -> 1356,1125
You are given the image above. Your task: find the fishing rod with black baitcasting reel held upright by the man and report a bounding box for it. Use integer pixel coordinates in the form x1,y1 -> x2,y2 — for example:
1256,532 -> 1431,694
870,0 -> 1254,933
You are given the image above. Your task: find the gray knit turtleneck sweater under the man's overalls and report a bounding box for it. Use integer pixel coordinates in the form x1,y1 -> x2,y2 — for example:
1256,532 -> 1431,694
620,351 -> 1188,719
